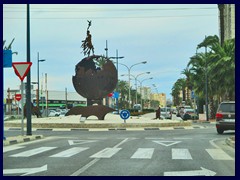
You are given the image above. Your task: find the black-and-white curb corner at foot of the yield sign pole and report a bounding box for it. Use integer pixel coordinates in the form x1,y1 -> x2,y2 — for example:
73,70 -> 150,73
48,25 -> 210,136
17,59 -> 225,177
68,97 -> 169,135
3,135 -> 44,146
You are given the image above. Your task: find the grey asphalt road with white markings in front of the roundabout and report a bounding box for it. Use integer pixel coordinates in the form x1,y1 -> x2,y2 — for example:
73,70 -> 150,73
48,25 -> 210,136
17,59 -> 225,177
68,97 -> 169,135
3,124 -> 235,176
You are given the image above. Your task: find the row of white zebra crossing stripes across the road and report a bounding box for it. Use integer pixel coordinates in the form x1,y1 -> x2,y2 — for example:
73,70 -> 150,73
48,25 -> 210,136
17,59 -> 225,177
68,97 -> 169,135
3,146 -> 234,160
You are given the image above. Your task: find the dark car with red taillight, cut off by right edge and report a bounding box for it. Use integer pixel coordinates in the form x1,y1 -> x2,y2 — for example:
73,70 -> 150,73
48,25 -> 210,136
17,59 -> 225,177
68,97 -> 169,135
216,101 -> 235,134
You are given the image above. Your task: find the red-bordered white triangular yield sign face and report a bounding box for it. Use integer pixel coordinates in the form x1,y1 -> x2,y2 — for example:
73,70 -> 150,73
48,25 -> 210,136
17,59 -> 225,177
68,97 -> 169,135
12,62 -> 32,81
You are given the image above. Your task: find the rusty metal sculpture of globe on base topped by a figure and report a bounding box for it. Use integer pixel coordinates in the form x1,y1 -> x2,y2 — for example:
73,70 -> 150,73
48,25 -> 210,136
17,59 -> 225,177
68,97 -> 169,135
66,21 -> 117,120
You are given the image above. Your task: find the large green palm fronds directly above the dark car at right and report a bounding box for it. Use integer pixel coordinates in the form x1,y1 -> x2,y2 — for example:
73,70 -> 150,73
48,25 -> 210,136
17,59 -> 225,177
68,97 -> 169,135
199,35 -> 235,100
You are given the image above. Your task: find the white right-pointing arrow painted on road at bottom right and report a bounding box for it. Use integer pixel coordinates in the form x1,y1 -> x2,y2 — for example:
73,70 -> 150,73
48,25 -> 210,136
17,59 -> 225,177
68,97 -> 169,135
164,167 -> 216,176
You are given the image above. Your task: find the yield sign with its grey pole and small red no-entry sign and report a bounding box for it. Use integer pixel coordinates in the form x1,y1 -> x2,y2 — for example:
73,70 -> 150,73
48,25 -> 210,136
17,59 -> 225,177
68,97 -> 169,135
12,62 -> 32,136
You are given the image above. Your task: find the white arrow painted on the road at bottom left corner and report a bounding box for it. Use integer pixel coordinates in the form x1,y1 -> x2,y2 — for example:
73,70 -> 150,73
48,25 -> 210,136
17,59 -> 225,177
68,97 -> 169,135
3,164 -> 47,176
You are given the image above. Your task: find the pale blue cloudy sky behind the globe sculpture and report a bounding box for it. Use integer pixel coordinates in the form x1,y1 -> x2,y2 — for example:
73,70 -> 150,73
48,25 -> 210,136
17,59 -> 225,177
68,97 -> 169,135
3,4 -> 219,98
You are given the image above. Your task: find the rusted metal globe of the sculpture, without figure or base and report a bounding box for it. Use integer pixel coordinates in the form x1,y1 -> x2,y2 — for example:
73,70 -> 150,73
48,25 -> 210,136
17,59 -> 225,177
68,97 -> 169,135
72,55 -> 117,100
